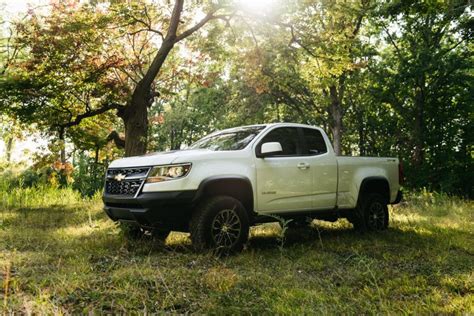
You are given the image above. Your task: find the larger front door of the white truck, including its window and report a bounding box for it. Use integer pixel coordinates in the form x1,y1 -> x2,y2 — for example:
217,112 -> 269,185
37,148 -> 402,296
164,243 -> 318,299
255,127 -> 313,213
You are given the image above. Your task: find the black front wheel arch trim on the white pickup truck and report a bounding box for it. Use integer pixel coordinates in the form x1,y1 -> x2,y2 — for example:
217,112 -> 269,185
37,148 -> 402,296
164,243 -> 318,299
195,175 -> 254,218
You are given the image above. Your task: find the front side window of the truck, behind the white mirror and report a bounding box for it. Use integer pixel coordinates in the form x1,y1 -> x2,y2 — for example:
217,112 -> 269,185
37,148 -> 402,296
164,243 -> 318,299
257,127 -> 301,157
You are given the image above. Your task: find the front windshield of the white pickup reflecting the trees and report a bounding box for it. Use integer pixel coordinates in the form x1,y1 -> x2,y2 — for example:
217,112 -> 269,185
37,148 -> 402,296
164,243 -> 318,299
189,126 -> 265,151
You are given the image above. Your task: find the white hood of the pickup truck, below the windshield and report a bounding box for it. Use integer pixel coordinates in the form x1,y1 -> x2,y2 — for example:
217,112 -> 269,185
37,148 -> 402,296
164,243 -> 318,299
109,149 -> 212,168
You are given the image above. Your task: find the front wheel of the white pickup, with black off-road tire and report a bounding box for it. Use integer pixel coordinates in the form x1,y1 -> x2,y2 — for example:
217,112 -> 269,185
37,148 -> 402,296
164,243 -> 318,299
190,196 -> 249,253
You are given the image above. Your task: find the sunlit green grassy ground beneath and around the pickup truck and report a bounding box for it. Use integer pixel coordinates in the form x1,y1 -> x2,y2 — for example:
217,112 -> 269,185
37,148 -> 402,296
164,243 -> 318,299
0,188 -> 474,314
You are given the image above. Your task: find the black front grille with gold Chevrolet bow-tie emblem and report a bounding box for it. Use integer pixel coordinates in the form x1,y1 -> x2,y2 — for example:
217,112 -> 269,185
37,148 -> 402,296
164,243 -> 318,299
105,167 -> 150,196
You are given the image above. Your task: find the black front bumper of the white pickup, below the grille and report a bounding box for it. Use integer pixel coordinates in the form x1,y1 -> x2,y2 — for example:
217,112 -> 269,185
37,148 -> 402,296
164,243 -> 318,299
102,190 -> 197,230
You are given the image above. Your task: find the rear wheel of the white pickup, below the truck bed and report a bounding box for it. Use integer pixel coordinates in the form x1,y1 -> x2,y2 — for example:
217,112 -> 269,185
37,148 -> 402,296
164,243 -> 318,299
349,193 -> 389,231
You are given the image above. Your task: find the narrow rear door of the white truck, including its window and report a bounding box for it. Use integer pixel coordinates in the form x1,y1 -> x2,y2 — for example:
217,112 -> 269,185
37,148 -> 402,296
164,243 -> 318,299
300,128 -> 337,210
